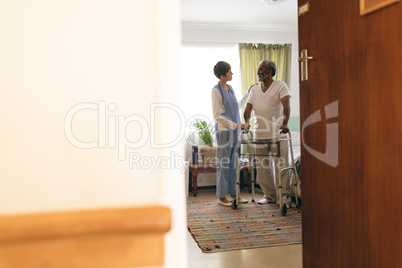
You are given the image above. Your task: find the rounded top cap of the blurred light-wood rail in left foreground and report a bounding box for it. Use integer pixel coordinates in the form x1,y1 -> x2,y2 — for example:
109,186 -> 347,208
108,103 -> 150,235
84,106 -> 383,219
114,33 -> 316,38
0,206 -> 171,243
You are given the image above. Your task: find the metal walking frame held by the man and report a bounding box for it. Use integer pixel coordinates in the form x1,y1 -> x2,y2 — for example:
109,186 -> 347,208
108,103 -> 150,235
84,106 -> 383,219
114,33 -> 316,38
232,129 -> 299,216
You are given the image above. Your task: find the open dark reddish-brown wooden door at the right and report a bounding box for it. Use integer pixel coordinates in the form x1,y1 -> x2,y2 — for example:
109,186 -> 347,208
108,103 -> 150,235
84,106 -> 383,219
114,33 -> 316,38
298,0 -> 402,268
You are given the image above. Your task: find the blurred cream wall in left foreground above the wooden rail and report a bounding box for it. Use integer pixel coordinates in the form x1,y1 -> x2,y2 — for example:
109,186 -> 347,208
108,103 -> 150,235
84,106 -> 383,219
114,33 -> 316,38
0,0 -> 186,268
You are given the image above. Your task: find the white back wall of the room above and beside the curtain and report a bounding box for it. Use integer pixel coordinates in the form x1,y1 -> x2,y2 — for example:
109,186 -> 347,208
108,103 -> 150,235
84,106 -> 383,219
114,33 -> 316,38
182,24 -> 300,186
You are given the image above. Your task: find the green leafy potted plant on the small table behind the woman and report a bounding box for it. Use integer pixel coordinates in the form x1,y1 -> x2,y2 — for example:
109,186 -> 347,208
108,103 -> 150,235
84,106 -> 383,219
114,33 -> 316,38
189,119 -> 216,164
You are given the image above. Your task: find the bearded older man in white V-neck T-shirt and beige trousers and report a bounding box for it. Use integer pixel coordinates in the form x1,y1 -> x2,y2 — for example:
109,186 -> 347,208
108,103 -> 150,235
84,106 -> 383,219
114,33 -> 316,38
244,60 -> 291,207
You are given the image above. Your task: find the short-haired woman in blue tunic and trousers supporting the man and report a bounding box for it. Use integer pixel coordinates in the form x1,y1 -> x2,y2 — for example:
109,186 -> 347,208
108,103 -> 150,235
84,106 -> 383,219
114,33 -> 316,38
211,61 -> 250,206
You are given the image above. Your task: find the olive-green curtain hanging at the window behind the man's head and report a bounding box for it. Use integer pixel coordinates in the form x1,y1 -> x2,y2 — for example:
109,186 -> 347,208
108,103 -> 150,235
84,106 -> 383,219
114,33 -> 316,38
239,43 -> 292,93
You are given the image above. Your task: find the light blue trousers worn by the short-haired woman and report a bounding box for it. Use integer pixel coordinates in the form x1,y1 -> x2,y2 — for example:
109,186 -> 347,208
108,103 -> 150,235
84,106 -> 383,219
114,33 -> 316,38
216,130 -> 238,198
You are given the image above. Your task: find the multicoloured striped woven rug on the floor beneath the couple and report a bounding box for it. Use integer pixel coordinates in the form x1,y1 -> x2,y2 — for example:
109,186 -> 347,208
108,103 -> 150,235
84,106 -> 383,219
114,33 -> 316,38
187,200 -> 302,253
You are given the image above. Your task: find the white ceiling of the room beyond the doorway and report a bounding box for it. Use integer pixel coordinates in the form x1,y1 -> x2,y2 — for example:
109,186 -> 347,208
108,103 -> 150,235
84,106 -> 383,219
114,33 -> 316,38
181,0 -> 297,30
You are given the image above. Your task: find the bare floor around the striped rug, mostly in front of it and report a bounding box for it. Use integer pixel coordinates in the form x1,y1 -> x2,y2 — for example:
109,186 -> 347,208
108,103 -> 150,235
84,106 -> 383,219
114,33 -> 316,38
187,189 -> 302,268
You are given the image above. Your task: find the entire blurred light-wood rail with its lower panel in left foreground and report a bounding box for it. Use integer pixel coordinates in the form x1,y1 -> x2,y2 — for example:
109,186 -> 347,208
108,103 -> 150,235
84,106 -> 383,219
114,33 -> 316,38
0,206 -> 171,268
